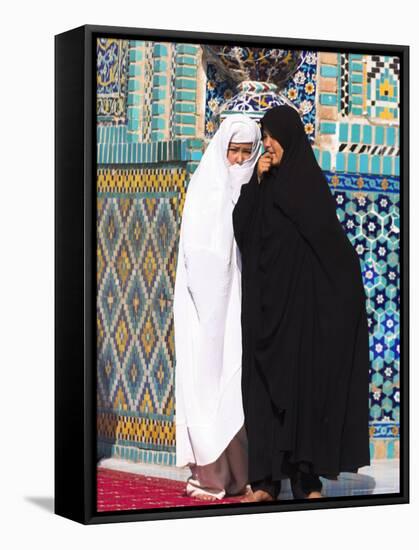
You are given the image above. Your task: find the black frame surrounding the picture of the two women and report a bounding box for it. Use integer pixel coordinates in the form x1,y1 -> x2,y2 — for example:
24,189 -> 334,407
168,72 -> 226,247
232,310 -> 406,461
55,25 -> 409,524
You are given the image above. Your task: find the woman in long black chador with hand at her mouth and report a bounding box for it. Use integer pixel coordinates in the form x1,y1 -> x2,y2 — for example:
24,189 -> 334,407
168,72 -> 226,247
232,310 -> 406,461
233,106 -> 370,501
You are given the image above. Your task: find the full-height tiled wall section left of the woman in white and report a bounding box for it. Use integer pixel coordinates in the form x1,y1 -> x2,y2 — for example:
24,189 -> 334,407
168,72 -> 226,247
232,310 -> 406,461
97,41 -> 207,465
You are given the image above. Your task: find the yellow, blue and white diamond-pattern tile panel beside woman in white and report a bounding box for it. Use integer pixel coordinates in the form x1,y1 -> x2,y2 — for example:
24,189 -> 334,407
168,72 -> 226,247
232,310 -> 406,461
97,167 -> 186,466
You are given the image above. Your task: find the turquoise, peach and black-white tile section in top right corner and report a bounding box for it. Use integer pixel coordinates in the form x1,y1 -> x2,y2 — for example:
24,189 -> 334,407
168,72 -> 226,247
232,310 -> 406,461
316,54 -> 400,176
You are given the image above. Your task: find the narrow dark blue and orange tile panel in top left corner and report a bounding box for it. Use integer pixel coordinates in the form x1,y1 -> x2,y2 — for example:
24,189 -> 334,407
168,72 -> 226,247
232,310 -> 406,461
96,38 -> 128,125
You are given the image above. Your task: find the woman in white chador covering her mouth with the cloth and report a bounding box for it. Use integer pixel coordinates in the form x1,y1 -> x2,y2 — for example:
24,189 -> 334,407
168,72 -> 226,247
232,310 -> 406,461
174,114 -> 261,499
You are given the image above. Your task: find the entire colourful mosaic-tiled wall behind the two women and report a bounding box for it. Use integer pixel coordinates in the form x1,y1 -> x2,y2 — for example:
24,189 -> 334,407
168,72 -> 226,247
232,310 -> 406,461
97,39 -> 400,464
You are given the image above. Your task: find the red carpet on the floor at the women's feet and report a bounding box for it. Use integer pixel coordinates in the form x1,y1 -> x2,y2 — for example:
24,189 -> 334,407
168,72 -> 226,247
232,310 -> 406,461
97,468 -> 248,512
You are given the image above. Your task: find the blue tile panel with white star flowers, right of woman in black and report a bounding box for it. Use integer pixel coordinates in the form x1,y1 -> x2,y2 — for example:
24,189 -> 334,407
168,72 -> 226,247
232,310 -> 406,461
332,188 -> 400,426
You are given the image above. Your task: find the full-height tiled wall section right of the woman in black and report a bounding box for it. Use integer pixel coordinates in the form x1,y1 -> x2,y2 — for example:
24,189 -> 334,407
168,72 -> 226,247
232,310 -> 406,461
314,53 -> 400,458
